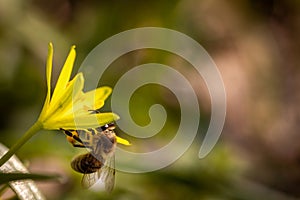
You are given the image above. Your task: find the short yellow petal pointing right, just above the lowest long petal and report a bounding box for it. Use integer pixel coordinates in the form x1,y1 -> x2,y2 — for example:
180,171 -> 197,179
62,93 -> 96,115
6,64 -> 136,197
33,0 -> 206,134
84,86 -> 112,110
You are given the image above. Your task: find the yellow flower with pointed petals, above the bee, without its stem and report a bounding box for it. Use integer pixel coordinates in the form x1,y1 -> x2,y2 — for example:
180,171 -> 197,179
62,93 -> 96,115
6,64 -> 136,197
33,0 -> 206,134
38,43 -> 129,145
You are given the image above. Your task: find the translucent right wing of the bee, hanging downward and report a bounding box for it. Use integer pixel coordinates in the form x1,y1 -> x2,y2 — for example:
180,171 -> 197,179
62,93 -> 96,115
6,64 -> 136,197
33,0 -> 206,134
100,155 -> 115,192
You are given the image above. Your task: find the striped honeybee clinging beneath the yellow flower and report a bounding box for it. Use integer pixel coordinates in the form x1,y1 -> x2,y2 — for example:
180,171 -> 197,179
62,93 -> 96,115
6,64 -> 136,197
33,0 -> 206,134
63,123 -> 117,192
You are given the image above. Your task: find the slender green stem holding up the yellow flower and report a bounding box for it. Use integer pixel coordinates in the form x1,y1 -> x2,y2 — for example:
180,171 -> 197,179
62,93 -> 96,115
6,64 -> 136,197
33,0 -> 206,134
0,121 -> 43,167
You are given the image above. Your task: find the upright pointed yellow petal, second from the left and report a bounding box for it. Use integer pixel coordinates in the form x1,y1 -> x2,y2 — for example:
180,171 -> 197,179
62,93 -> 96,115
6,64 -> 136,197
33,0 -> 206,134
52,46 -> 76,103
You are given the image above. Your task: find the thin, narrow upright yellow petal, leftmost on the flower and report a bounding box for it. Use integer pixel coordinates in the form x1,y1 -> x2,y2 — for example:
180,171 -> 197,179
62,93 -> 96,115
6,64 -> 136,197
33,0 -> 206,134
41,42 -> 53,119
